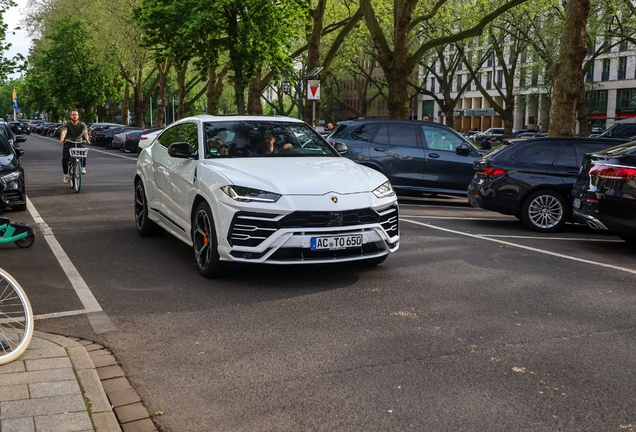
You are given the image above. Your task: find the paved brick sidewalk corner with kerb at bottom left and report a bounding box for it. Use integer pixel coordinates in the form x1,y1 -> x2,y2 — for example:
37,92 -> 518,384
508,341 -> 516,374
0,331 -> 156,432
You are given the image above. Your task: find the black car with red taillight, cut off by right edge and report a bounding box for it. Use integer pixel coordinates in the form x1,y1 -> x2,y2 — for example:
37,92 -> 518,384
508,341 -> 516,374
572,142 -> 636,245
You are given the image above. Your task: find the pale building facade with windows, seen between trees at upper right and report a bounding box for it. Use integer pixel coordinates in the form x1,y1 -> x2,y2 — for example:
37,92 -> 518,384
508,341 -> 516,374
418,42 -> 636,132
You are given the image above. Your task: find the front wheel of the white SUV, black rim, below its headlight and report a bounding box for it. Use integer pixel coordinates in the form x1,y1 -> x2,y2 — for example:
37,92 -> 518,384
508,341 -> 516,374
192,201 -> 227,278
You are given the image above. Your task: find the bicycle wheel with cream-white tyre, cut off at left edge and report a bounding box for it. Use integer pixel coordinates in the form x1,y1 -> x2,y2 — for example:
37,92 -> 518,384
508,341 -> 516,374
0,269 -> 33,365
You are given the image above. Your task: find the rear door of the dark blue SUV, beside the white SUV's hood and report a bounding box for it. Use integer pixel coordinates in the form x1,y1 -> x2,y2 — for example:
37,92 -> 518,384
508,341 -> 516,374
369,122 -> 426,191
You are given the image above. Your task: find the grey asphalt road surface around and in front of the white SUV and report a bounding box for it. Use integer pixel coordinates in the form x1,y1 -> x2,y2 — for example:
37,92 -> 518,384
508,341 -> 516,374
0,135 -> 636,432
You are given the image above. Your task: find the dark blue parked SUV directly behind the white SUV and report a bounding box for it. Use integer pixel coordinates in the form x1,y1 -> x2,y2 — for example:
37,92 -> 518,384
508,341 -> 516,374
327,119 -> 481,197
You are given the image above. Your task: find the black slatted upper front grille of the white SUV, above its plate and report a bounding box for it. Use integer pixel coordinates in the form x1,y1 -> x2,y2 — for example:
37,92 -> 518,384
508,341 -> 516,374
227,205 -> 398,247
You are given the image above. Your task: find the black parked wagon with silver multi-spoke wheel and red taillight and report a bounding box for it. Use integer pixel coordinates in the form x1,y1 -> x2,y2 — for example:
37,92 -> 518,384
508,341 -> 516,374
468,137 -> 625,232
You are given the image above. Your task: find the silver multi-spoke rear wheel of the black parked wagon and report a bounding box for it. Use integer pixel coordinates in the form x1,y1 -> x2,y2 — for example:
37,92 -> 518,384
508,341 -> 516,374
521,190 -> 570,232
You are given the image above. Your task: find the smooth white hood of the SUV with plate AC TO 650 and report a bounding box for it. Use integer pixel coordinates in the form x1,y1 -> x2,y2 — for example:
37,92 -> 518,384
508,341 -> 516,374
205,157 -> 387,195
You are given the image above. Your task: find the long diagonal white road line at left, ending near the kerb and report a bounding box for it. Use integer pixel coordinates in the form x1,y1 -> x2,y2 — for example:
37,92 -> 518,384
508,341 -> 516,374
27,197 -> 115,333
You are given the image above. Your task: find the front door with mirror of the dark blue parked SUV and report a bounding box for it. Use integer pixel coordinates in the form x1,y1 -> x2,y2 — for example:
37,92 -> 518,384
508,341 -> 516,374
420,125 -> 479,193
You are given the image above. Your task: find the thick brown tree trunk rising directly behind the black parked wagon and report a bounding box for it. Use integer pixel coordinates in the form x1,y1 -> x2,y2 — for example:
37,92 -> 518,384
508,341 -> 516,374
548,0 -> 591,136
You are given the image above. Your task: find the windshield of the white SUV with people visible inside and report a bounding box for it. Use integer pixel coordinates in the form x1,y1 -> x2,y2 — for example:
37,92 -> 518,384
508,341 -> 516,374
204,121 -> 340,159
